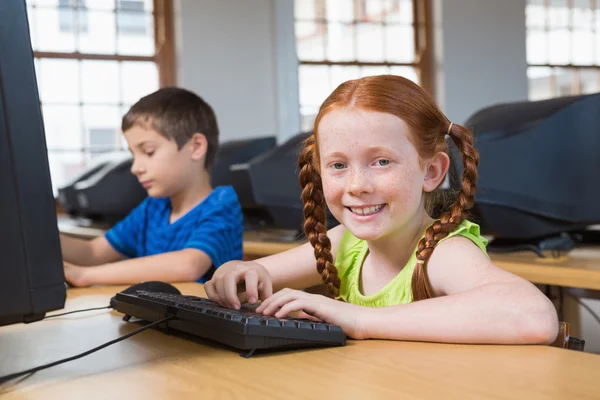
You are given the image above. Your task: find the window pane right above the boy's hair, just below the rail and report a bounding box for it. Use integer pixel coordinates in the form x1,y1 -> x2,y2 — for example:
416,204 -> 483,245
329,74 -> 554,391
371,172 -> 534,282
121,61 -> 158,104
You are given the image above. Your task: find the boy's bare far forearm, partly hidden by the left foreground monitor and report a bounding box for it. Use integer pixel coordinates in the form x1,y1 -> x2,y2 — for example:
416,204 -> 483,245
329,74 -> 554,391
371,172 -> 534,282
60,233 -> 123,266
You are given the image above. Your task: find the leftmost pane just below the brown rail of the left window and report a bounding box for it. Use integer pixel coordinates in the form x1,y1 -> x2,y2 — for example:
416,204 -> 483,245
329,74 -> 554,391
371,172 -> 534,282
38,58 -> 80,104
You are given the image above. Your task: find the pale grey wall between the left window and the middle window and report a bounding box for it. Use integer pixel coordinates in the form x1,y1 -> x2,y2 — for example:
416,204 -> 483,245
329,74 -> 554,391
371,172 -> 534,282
174,0 -> 300,142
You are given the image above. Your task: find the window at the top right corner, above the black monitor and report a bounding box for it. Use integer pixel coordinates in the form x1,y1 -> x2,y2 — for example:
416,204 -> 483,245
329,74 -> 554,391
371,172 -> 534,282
526,0 -> 600,100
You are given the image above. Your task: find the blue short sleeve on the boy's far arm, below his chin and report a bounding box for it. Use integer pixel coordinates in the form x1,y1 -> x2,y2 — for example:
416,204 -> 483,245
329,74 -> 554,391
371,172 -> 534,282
104,197 -> 150,258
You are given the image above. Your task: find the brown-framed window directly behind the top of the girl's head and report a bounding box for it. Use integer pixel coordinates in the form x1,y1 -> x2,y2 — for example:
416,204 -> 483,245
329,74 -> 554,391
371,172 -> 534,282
295,0 -> 431,130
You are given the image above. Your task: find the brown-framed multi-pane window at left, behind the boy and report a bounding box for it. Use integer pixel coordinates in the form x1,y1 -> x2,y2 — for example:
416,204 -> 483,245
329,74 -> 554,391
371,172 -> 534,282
27,0 -> 175,192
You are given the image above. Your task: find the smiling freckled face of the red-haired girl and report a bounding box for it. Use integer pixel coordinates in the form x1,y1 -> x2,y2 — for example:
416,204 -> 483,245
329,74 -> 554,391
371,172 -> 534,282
317,109 -> 425,240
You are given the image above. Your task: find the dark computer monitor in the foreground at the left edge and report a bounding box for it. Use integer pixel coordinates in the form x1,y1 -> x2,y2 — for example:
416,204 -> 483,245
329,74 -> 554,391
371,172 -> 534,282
0,0 -> 66,325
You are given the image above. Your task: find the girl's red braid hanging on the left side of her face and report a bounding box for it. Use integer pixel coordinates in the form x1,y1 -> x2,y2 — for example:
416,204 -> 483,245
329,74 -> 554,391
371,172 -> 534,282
298,135 -> 340,298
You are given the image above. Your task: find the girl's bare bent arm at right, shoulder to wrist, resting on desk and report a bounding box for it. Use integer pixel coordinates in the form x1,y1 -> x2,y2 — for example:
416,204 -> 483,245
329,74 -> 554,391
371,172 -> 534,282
357,237 -> 558,344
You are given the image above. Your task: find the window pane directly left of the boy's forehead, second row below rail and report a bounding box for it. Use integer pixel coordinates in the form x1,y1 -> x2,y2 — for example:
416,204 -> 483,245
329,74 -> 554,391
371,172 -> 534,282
83,105 -> 121,152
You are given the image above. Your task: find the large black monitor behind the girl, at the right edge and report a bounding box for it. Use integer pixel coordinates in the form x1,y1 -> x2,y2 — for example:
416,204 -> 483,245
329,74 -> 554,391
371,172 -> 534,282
452,93 -> 600,252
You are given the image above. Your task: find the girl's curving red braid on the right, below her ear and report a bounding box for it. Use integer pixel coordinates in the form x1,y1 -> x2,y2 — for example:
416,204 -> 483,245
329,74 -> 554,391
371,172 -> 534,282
411,124 -> 479,301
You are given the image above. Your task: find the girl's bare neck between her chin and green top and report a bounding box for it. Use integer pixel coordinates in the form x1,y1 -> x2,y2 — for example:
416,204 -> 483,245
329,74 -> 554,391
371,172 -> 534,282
368,210 -> 434,271
